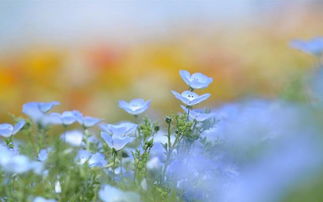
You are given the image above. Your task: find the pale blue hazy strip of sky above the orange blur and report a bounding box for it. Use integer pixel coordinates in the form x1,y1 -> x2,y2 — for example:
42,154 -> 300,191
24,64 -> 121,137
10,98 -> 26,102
0,0 -> 323,48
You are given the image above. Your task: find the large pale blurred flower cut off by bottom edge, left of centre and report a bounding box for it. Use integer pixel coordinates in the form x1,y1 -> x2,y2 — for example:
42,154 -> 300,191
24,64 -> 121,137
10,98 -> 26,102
99,185 -> 141,202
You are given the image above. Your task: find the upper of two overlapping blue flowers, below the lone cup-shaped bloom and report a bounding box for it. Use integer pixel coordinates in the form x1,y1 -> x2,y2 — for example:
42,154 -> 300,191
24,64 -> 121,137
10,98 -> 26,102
100,122 -> 137,137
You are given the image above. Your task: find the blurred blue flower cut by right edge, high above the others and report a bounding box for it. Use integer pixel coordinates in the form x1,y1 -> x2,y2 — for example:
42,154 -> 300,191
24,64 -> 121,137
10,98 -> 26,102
290,37 -> 323,56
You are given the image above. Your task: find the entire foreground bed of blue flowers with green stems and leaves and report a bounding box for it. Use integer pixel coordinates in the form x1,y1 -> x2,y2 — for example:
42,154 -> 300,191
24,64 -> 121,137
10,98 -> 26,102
0,40 -> 323,202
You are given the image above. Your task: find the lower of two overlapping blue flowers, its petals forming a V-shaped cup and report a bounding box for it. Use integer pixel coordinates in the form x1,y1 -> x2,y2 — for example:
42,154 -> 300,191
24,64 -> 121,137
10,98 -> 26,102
101,131 -> 133,151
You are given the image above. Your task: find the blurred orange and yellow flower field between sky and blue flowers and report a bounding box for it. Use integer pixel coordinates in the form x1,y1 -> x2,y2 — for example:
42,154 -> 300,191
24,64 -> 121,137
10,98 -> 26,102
0,1 -> 323,121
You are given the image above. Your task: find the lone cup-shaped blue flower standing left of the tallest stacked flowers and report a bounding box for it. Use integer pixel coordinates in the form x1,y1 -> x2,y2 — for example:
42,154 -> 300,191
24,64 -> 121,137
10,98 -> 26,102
119,98 -> 150,115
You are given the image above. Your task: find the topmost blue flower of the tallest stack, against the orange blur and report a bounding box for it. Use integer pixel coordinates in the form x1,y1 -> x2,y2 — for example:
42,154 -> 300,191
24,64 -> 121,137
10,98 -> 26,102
179,70 -> 213,89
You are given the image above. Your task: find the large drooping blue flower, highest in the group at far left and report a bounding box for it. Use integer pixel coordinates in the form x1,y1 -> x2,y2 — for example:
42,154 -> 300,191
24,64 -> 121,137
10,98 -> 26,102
22,101 -> 60,123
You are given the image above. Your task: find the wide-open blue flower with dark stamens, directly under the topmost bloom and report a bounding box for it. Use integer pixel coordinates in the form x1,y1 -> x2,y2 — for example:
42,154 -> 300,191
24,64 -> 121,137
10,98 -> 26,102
172,90 -> 211,106
